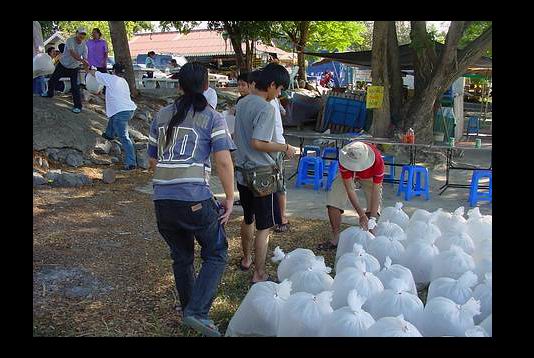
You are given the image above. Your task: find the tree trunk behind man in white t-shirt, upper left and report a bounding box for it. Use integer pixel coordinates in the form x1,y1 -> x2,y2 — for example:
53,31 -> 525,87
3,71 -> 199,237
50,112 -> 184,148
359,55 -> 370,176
108,21 -> 139,98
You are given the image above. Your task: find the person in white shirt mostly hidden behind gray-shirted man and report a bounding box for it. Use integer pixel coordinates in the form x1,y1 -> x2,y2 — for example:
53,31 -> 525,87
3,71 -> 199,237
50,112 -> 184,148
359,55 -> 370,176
269,94 -> 289,232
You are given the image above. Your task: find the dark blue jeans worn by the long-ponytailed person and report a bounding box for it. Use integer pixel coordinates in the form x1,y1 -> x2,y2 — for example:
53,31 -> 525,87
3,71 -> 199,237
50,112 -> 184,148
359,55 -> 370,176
154,198 -> 228,319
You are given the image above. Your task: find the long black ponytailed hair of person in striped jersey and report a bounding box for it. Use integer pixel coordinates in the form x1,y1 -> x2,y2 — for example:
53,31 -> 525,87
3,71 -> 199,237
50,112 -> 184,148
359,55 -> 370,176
165,62 -> 208,147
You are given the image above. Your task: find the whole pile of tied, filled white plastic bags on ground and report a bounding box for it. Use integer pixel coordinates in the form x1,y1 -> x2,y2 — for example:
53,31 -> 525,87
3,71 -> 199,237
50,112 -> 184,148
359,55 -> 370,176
226,203 -> 492,337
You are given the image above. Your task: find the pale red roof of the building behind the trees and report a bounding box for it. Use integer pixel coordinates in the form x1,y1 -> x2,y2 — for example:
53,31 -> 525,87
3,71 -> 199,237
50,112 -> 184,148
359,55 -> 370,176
129,30 -> 291,57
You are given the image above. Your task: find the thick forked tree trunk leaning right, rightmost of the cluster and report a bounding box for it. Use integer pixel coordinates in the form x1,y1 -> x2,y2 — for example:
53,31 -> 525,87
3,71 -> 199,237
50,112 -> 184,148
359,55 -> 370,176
406,21 -> 492,143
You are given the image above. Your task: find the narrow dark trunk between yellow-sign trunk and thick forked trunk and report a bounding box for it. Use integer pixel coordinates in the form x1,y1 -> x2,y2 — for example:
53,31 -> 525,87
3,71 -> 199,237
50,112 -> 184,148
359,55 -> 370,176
387,21 -> 404,126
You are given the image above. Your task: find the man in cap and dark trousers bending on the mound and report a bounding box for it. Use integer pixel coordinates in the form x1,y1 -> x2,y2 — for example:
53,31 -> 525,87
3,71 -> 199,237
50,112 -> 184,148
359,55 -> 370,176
43,27 -> 89,113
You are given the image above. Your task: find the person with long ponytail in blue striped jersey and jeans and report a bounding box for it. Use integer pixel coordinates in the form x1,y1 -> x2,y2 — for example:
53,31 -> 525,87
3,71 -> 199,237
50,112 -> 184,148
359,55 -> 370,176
148,62 -> 235,337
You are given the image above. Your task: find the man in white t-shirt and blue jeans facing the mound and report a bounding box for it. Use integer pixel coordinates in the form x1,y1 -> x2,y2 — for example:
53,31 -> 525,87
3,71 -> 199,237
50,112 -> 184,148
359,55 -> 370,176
86,63 -> 137,170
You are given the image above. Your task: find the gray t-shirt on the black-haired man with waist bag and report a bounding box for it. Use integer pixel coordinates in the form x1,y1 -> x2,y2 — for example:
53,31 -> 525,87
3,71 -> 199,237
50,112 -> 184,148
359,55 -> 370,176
234,94 -> 277,185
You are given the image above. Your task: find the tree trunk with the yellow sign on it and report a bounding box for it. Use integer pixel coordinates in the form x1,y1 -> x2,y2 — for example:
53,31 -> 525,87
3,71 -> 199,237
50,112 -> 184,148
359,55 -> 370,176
370,21 -> 391,137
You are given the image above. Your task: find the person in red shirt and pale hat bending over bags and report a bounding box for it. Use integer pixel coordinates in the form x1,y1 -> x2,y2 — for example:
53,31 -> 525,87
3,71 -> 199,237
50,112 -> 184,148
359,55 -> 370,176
317,141 -> 384,251
